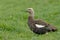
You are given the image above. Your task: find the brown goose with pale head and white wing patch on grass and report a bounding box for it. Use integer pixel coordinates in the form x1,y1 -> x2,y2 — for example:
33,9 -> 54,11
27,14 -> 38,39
27,8 -> 57,34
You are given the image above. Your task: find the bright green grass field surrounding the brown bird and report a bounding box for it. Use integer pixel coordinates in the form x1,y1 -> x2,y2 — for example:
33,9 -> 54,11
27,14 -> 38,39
0,0 -> 60,40
